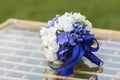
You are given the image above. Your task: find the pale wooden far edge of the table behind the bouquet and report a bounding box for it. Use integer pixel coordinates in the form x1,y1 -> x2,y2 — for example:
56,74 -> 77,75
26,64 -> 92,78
0,19 -> 120,40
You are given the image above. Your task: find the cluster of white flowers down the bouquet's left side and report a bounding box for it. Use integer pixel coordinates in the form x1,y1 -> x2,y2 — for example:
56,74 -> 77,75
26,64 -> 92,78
40,27 -> 59,61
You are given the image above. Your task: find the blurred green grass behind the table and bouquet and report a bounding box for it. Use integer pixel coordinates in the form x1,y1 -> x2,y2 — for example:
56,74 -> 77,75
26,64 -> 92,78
0,0 -> 120,30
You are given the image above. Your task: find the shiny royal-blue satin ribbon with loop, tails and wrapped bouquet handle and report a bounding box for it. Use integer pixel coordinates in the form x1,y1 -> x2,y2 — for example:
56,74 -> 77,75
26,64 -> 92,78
50,37 -> 103,76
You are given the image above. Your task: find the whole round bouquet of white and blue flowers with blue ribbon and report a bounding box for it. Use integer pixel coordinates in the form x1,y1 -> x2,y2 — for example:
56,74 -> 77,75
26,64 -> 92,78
40,12 -> 103,76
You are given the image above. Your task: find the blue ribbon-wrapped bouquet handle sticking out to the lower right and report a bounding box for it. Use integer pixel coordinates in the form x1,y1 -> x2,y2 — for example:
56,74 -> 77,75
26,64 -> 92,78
84,52 -> 103,66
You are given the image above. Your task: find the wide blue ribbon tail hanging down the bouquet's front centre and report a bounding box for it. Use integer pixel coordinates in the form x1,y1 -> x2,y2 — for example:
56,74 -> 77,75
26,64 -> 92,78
61,45 -> 84,76
